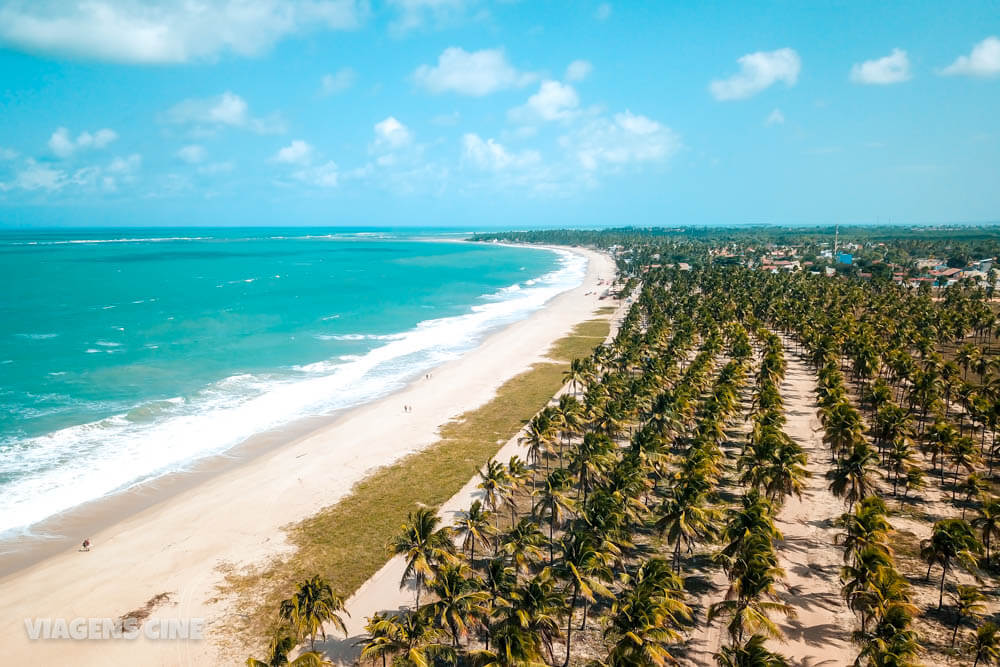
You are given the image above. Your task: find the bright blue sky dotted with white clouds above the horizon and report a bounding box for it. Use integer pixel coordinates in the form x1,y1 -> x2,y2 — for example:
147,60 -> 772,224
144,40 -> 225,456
0,0 -> 1000,229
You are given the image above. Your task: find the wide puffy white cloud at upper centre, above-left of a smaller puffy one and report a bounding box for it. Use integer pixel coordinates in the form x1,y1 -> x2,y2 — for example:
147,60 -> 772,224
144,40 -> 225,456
413,46 -> 536,97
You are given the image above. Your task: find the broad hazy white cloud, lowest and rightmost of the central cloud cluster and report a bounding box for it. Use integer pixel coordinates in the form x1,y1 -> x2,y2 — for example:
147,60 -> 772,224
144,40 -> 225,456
560,111 -> 681,171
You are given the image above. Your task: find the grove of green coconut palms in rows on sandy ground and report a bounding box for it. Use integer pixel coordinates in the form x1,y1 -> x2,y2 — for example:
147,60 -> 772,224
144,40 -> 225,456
254,228 -> 1000,667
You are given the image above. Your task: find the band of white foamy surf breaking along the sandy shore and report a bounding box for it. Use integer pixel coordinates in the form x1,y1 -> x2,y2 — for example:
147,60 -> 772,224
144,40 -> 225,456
0,251 -> 586,532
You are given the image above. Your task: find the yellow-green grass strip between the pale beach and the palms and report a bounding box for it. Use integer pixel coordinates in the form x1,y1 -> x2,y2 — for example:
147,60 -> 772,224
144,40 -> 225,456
220,319 -> 610,648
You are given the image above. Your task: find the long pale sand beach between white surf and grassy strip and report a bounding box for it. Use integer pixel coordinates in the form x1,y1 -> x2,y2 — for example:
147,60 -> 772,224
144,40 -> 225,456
0,250 -> 614,665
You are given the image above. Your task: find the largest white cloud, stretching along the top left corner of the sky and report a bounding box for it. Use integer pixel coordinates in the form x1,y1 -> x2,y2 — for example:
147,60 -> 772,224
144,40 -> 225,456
0,0 -> 368,63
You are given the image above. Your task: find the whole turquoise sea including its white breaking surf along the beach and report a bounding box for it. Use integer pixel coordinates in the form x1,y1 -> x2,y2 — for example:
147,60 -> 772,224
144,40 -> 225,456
0,228 -> 584,532
